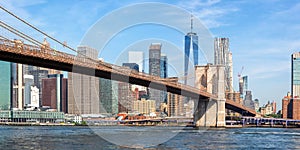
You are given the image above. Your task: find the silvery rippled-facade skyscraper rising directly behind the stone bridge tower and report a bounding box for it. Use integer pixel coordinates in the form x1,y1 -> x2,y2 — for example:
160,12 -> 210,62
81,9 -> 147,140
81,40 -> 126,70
214,38 -> 233,92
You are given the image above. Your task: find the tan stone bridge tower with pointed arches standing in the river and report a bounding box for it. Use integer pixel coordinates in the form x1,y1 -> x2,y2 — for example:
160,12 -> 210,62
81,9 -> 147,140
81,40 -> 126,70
194,64 -> 226,127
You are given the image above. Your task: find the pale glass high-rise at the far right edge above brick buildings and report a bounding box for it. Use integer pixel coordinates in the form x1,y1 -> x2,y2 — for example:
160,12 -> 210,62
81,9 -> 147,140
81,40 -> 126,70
292,52 -> 300,97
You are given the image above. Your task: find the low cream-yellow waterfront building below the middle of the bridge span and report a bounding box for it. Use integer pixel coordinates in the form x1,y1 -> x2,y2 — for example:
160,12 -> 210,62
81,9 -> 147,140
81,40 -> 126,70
133,98 -> 156,115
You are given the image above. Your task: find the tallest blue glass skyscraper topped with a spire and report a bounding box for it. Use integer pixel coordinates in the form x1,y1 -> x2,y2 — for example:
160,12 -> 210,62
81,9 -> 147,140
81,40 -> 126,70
184,17 -> 199,84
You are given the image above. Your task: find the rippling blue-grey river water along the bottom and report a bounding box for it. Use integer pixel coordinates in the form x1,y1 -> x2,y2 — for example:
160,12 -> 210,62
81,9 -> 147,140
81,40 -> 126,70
0,126 -> 300,150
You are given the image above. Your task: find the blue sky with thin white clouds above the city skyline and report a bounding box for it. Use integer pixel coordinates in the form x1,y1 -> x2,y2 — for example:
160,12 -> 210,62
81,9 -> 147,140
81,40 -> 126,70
0,0 -> 300,109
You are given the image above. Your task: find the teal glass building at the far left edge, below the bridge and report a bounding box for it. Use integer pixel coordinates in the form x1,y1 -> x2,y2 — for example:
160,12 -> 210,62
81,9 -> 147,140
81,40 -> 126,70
0,61 -> 12,110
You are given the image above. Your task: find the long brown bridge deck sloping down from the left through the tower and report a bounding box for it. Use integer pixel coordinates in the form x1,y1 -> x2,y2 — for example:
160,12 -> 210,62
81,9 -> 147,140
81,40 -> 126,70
0,39 -> 255,116
